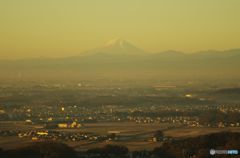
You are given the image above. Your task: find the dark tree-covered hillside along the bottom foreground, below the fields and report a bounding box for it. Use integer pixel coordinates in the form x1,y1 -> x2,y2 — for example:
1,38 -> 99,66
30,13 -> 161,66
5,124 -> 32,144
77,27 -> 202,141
0,132 -> 240,158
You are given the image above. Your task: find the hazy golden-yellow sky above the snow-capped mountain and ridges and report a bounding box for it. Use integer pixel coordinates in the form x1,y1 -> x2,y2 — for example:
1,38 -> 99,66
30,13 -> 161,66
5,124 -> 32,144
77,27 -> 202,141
0,0 -> 240,58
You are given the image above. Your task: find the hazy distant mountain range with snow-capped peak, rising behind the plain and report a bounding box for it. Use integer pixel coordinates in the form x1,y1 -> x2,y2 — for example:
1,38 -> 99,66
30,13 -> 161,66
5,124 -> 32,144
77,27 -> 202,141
0,39 -> 240,78
